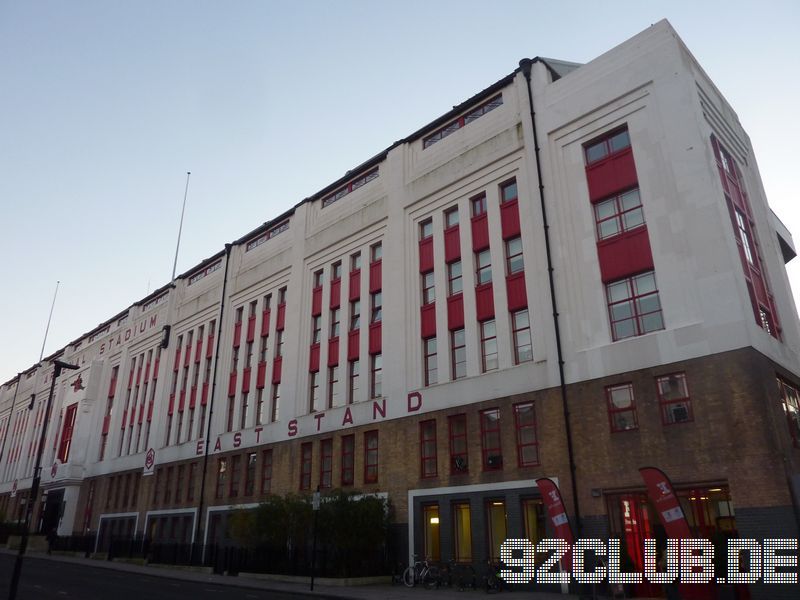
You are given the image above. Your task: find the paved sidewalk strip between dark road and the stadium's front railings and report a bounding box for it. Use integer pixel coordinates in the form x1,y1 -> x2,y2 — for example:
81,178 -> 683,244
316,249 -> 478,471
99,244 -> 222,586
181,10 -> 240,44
0,548 -> 592,600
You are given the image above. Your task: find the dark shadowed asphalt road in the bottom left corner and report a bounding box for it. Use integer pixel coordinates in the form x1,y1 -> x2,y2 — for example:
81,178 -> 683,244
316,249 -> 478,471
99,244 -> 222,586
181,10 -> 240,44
0,554 -> 299,600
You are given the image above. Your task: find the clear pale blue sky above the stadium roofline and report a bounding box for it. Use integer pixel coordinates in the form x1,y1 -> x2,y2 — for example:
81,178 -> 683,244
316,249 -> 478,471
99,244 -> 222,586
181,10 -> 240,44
0,0 -> 800,382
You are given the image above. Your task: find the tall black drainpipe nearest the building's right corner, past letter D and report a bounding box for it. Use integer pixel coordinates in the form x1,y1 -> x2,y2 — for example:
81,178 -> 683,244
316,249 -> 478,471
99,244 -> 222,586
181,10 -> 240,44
519,58 -> 582,537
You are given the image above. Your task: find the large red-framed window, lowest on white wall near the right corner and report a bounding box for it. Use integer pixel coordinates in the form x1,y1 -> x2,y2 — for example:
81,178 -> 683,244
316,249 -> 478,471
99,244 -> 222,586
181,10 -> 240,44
606,271 -> 664,341
